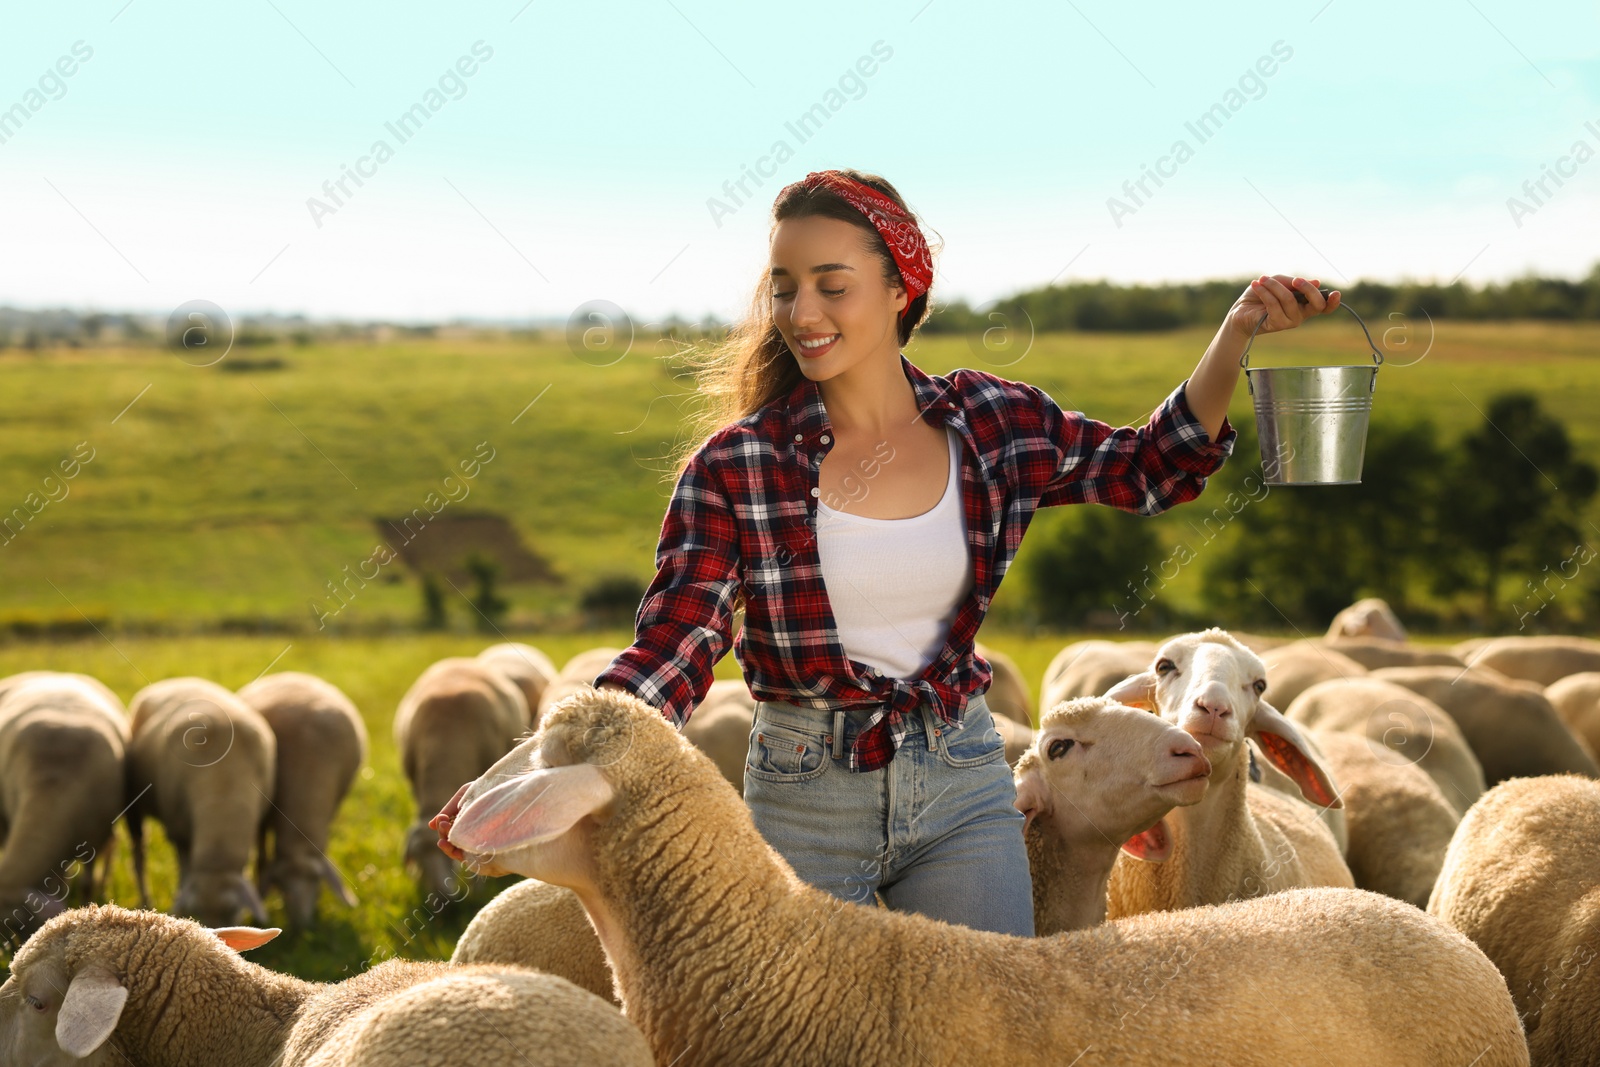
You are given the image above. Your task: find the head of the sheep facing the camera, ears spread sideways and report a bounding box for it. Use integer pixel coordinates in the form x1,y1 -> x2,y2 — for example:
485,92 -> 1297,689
1106,627 -> 1342,808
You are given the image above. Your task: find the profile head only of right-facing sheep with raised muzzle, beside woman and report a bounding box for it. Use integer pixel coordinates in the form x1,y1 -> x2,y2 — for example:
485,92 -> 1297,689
1016,696 -> 1211,861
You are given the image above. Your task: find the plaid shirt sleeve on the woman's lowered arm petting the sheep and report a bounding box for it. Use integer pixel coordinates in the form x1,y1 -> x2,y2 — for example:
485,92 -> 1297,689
594,450 -> 741,728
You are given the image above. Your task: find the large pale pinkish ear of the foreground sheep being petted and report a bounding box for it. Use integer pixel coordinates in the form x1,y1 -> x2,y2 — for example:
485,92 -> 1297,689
450,763 -> 616,853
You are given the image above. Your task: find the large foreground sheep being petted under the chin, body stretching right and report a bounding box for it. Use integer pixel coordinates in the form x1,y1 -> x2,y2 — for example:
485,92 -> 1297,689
434,689 -> 1526,1067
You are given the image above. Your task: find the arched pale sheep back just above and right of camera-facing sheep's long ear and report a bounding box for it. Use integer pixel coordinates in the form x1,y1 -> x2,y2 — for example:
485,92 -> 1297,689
1283,675 -> 1485,814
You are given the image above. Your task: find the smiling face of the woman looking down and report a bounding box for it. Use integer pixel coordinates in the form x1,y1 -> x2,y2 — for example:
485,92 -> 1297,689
771,216 -> 909,381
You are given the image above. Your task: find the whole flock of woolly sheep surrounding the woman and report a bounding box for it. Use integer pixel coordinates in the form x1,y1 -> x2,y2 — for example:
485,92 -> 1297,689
0,601 -> 1600,1067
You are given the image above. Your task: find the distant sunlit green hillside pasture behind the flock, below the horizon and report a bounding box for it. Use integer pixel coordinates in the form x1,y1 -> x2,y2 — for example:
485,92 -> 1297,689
0,315 -> 1600,630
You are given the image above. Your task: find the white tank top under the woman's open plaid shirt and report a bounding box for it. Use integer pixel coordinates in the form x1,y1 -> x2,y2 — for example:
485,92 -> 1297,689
816,426 -> 973,678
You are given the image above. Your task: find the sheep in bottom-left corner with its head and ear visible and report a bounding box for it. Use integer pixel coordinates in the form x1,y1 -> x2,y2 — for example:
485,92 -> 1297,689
0,904 -> 588,1067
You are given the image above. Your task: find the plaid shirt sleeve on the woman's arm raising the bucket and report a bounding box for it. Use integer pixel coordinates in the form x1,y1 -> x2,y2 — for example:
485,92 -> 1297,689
1029,378 -> 1238,515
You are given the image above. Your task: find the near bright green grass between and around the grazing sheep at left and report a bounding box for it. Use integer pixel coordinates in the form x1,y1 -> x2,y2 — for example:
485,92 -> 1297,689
0,625 -> 1478,981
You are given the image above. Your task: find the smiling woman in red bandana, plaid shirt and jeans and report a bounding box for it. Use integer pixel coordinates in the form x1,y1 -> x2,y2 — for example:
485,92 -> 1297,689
563,171 -> 1338,936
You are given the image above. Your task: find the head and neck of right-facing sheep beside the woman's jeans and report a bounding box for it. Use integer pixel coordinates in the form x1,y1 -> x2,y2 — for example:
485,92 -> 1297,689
1014,696 -> 1211,936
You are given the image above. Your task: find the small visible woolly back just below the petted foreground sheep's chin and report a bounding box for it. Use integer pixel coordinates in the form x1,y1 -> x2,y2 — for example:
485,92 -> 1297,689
450,878 -> 619,1003
